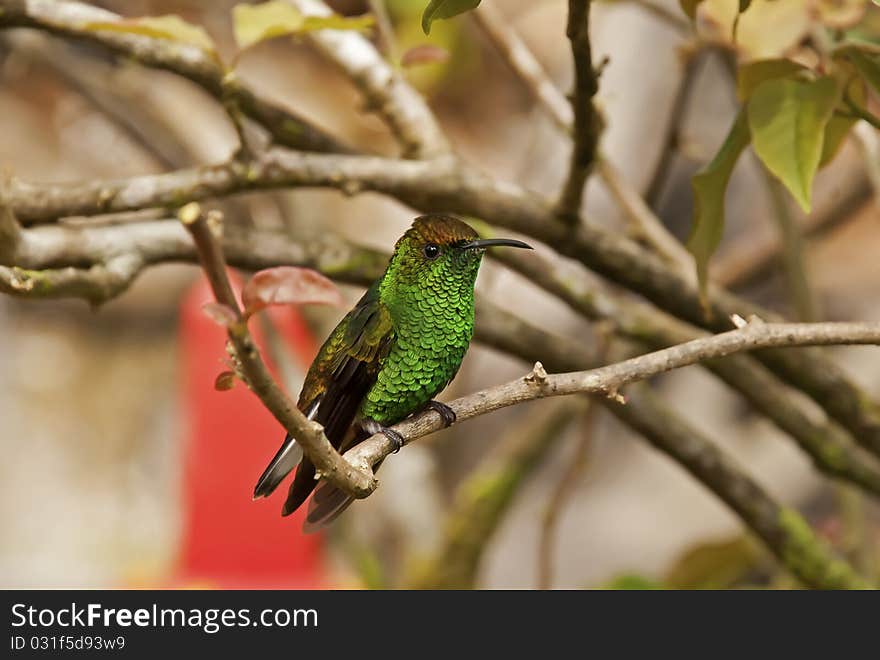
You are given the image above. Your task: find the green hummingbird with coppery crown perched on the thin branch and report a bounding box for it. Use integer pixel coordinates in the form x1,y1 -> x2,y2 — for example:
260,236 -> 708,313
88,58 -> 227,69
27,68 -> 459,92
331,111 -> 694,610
254,214 -> 531,533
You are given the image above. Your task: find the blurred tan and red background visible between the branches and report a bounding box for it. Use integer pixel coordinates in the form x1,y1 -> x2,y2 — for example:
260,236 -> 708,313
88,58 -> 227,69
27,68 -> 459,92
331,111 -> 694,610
0,0 -> 880,588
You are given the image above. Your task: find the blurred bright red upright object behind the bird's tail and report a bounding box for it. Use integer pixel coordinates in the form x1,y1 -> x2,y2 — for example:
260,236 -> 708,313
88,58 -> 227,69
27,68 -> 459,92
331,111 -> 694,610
173,280 -> 325,589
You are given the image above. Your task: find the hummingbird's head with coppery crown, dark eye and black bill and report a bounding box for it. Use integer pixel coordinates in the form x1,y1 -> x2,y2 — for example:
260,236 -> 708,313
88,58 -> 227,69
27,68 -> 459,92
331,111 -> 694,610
383,214 -> 531,310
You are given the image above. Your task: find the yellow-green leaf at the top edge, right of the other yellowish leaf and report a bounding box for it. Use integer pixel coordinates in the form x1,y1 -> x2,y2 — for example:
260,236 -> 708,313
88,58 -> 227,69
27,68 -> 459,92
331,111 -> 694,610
232,0 -> 374,50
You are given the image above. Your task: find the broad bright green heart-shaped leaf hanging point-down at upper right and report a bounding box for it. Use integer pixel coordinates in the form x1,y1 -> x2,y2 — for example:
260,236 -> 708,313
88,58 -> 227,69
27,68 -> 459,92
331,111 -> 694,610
747,76 -> 841,211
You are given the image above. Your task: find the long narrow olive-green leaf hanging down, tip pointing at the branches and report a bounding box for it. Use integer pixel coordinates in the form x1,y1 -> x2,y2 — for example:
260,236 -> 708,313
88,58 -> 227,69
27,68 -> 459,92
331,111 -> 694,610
687,110 -> 749,305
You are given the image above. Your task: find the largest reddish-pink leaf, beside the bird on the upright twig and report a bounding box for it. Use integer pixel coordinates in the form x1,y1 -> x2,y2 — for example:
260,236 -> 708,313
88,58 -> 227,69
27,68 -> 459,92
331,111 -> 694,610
248,266 -> 342,315
